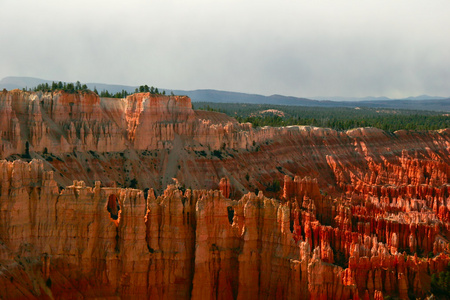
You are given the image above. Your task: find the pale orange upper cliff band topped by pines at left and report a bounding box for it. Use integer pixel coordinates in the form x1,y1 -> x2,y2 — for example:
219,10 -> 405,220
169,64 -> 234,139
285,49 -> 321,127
0,90 -> 261,157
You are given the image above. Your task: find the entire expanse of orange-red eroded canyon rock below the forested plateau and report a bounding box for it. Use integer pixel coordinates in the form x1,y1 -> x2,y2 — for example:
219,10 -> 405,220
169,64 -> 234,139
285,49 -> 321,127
0,90 -> 450,299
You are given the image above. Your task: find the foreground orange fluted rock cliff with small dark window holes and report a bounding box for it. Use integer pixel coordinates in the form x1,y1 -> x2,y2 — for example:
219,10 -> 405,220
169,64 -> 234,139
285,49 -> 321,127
0,160 -> 450,299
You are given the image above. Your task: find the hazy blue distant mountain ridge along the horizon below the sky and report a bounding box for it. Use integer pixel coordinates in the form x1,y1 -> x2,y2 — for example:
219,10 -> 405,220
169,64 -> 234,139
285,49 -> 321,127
0,76 -> 450,112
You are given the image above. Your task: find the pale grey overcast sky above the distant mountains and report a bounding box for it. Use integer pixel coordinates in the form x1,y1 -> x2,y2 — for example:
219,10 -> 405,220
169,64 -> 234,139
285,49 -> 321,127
0,0 -> 450,98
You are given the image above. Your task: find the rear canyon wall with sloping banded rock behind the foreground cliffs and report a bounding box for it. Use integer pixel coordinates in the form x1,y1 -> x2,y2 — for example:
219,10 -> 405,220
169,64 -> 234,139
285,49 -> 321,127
0,90 -> 450,198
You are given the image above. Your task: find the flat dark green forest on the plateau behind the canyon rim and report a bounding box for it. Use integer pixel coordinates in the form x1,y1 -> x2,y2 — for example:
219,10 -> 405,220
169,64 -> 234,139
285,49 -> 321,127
195,102 -> 450,132
